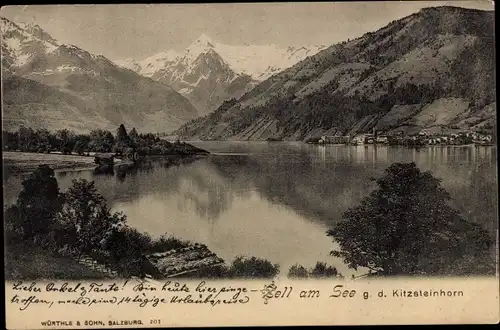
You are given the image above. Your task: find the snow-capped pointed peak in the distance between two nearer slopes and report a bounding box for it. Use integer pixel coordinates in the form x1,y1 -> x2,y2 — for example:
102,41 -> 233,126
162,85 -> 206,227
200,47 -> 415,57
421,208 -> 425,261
116,35 -> 326,114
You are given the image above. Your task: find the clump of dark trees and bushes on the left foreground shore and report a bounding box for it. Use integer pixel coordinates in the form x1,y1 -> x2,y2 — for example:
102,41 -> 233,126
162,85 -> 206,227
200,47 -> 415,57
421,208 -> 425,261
4,166 -> 217,277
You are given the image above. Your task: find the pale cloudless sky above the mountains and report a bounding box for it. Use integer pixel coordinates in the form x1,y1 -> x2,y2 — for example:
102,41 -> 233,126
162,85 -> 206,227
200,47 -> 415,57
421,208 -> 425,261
0,0 -> 494,60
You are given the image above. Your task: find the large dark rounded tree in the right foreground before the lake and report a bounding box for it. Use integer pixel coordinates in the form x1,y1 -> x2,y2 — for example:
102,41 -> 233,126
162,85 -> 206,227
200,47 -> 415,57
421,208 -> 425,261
328,163 -> 492,275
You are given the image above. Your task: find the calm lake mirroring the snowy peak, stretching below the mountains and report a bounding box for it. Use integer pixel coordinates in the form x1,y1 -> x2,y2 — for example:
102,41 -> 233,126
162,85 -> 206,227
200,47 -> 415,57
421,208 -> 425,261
4,141 -> 497,276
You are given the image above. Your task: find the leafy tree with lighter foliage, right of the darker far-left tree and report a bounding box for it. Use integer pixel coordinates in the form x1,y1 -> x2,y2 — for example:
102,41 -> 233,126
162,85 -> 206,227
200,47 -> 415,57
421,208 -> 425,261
57,179 -> 126,253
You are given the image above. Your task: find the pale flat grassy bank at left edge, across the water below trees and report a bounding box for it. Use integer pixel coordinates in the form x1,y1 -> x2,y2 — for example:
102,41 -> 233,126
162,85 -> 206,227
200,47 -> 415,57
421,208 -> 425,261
2,151 -> 96,173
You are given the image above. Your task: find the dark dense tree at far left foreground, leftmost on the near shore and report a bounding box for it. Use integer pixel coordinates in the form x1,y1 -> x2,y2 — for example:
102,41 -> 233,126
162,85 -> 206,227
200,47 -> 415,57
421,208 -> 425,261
7,165 -> 64,240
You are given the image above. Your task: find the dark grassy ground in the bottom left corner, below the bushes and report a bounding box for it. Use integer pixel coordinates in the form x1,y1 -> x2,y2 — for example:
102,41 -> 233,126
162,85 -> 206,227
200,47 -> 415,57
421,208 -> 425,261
4,243 -> 106,281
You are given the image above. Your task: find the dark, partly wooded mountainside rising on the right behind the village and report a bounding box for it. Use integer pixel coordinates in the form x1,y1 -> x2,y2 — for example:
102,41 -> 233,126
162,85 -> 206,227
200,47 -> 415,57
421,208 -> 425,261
177,7 -> 496,140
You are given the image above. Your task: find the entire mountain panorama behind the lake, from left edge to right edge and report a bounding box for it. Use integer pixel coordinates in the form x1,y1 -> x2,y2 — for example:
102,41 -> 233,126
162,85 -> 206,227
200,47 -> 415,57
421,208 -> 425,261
2,6 -> 496,141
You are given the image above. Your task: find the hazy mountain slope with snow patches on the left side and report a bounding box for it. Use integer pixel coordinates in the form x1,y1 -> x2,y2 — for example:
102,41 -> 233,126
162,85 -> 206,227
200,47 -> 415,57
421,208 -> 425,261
2,18 -> 198,132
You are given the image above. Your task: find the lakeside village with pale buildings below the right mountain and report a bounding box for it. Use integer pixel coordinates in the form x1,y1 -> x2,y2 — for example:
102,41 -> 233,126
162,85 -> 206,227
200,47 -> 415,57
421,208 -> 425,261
306,129 -> 494,146
